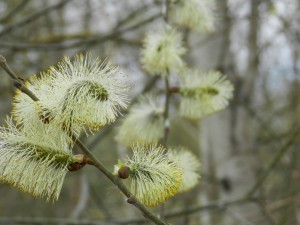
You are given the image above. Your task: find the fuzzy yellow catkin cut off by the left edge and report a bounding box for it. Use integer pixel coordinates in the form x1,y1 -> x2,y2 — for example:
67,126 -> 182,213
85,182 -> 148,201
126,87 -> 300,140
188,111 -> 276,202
0,119 -> 72,201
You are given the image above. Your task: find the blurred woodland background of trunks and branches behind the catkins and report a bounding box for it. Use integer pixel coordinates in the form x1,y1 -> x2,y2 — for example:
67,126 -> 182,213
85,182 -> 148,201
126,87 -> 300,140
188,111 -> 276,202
0,0 -> 300,225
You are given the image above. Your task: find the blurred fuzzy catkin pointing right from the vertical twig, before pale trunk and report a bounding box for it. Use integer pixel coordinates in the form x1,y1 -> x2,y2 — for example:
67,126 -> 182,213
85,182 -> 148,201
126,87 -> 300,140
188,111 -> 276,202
179,68 -> 233,119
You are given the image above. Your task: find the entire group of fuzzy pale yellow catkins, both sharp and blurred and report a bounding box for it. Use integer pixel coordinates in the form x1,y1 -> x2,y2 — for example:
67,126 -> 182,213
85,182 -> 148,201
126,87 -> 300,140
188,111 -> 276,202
0,0 -> 233,209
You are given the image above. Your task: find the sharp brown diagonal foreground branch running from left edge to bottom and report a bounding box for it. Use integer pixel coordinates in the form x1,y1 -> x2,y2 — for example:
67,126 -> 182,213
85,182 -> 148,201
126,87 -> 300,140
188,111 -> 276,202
0,55 -> 167,225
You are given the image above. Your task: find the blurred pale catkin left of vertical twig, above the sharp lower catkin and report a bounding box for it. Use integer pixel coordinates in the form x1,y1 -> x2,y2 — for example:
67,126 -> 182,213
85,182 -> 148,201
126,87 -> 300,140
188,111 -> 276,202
116,93 -> 164,146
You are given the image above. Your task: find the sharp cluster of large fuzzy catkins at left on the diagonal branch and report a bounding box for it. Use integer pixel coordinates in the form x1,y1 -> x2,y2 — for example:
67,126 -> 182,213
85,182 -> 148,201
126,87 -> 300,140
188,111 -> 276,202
0,55 -> 129,200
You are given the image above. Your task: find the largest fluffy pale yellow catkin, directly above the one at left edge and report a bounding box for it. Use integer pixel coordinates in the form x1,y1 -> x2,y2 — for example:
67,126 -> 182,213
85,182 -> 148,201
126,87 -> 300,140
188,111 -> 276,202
13,54 -> 129,133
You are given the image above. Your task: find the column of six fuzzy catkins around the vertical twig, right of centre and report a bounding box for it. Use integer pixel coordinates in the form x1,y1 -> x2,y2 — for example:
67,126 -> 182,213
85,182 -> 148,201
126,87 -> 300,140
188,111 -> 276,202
115,0 -> 233,206
